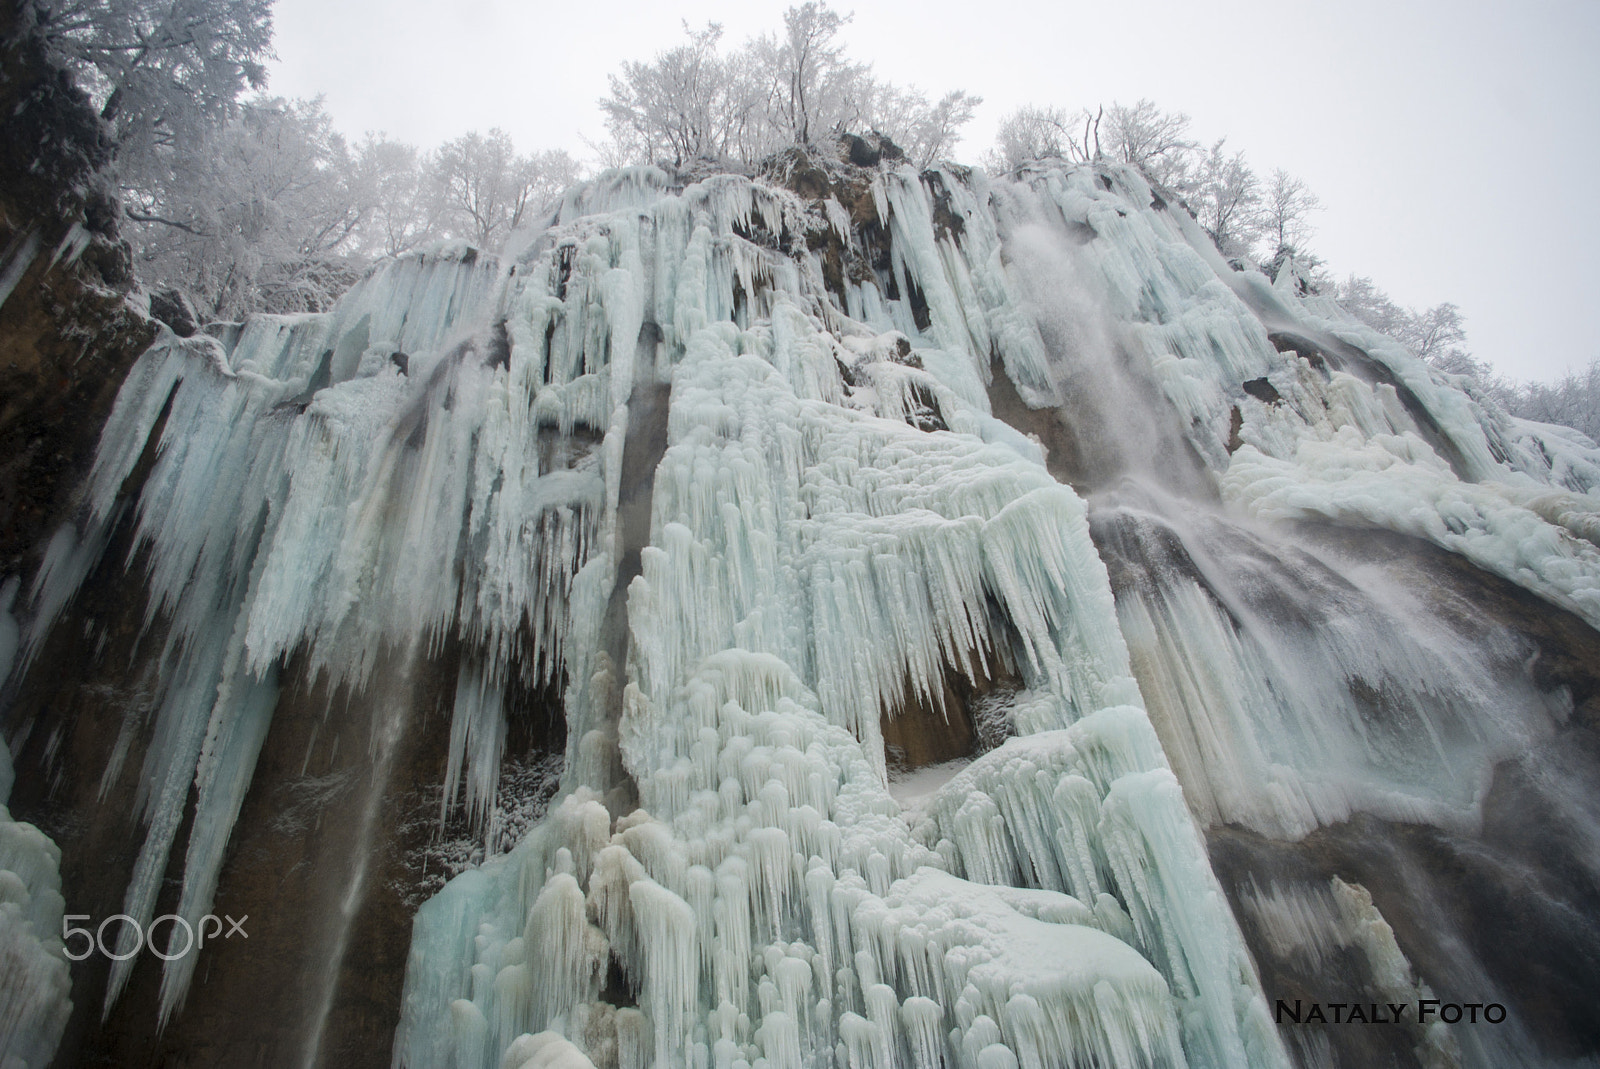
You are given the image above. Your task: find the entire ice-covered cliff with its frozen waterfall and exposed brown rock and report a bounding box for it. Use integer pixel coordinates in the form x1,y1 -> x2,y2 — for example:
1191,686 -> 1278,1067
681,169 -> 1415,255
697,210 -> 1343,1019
8,154 -> 1600,1069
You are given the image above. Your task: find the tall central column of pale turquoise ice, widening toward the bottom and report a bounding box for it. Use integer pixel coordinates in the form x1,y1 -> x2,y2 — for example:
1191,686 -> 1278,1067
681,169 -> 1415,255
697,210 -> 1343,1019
397,164 -> 1283,1069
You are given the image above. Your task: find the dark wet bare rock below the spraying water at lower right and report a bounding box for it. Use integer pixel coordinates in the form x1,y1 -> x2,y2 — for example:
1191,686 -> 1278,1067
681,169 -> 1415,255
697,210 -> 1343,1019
1206,525 -> 1600,1066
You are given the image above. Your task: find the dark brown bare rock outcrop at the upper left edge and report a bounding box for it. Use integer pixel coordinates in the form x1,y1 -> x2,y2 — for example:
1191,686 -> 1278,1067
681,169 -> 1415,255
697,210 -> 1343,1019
0,0 -> 157,576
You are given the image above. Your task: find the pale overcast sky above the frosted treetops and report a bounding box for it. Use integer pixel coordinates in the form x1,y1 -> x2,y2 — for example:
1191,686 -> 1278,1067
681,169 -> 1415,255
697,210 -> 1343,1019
270,0 -> 1600,379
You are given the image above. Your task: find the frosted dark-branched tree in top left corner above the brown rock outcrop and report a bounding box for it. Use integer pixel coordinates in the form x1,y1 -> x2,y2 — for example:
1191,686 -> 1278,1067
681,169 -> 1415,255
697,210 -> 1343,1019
22,0 -> 272,182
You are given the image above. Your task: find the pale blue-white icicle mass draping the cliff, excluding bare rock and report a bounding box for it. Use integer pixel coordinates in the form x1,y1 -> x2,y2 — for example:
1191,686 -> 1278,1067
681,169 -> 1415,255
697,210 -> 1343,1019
12,152 -> 1600,1069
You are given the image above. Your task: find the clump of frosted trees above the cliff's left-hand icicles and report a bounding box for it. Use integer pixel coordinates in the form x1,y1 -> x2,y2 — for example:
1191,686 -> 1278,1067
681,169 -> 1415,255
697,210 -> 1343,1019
125,107 -> 579,318
